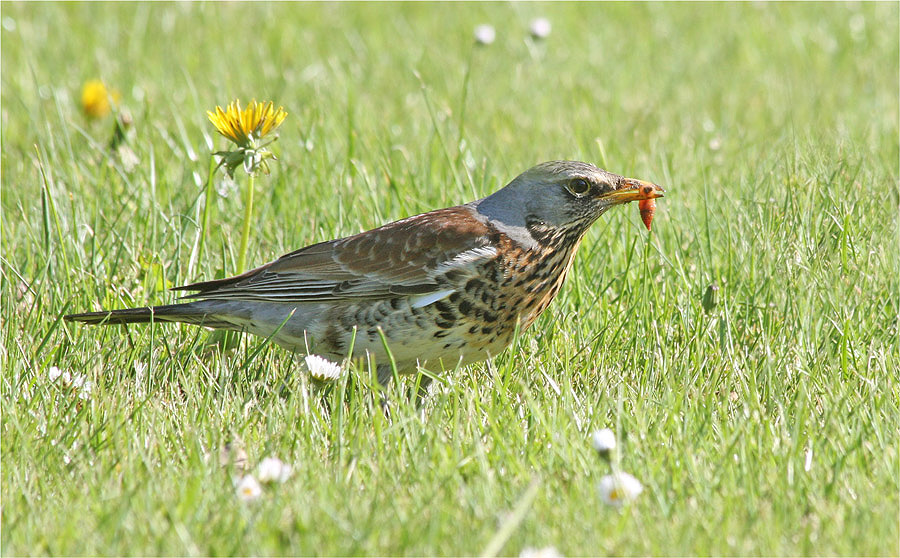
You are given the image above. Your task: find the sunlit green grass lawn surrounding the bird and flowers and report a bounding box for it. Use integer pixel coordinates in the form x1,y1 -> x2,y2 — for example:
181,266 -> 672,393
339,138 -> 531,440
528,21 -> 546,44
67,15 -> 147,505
0,3 -> 900,555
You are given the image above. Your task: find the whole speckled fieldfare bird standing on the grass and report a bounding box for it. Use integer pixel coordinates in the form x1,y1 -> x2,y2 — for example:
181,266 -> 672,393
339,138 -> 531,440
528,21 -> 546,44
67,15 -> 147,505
66,161 -> 663,385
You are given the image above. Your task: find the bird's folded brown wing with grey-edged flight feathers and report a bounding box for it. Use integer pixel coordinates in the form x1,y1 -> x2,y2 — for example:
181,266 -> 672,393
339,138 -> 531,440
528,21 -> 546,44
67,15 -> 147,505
177,206 -> 497,302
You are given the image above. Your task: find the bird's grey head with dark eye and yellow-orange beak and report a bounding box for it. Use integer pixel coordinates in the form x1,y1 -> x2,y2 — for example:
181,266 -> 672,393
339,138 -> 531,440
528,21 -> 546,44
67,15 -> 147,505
473,161 -> 663,243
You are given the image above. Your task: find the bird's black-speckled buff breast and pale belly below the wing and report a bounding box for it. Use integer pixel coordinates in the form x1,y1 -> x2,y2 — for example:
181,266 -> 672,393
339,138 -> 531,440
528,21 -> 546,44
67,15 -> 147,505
302,224 -> 581,372
